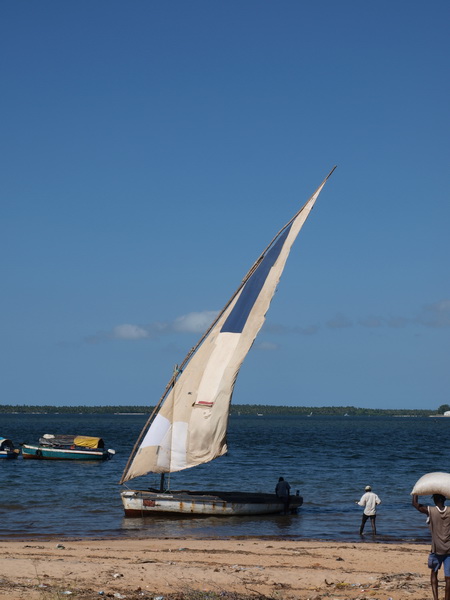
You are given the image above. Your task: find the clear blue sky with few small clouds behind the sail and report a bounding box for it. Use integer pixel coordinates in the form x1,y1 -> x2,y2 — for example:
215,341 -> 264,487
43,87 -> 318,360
0,0 -> 450,408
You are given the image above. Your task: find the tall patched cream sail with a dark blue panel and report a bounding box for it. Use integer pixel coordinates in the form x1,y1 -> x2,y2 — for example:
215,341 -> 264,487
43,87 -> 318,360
121,169 -> 334,483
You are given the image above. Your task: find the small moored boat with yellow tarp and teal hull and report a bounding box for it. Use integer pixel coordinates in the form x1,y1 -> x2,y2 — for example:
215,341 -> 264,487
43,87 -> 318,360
22,433 -> 115,460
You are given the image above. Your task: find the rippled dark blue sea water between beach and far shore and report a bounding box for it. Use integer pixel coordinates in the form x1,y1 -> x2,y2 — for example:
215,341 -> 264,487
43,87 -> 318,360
0,414 -> 444,542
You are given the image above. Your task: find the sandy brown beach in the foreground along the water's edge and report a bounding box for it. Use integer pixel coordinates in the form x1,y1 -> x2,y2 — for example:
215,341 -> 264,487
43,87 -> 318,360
0,538 -> 431,600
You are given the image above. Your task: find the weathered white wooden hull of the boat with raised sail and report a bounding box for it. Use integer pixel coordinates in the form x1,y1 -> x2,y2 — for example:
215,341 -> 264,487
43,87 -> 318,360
121,490 -> 303,517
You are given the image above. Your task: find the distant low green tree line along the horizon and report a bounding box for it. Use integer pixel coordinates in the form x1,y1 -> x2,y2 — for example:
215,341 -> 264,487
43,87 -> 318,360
0,404 -> 442,417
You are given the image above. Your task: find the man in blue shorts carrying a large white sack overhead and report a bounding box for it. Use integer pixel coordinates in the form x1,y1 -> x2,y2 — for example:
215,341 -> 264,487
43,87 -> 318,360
412,494 -> 450,600
